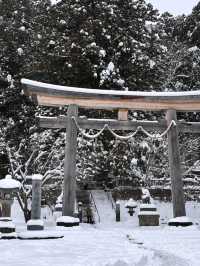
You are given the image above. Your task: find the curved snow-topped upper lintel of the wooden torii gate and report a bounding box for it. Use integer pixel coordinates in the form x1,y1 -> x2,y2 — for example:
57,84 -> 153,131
21,79 -> 200,111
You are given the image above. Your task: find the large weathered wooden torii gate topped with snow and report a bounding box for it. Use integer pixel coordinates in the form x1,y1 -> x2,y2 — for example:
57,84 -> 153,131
21,79 -> 200,217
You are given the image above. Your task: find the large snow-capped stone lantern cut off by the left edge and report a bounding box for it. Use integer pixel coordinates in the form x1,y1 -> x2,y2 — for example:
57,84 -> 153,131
0,175 -> 21,234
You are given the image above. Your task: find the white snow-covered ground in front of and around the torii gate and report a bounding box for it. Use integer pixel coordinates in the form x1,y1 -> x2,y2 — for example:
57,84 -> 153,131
0,201 -> 200,266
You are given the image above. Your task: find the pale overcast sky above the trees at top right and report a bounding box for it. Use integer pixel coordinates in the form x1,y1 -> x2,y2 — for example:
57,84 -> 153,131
147,0 -> 200,15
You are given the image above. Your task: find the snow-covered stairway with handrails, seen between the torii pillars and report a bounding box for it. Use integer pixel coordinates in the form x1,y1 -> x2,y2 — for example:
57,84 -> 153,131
91,190 -> 115,223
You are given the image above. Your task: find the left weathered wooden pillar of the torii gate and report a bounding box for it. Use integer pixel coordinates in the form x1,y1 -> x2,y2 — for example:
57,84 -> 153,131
63,105 -> 78,216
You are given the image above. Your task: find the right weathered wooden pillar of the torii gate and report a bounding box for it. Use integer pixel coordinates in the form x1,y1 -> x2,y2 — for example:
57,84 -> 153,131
166,110 -> 186,217
